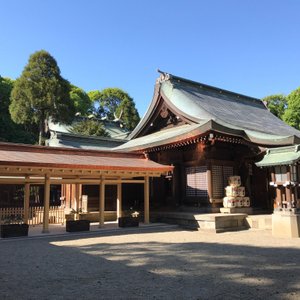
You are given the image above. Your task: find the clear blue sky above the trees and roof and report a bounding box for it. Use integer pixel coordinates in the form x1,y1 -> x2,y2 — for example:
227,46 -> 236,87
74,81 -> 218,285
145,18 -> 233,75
0,0 -> 300,115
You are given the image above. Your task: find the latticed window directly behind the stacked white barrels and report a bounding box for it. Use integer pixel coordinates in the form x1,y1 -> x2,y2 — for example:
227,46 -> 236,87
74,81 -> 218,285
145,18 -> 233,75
212,166 -> 233,199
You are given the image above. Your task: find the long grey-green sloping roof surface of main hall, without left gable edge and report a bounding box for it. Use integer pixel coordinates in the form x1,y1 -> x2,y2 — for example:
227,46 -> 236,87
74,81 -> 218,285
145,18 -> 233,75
161,79 -> 300,136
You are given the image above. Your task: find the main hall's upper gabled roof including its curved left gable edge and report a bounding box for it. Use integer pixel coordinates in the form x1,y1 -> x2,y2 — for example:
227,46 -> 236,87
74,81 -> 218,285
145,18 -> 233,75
130,73 -> 300,145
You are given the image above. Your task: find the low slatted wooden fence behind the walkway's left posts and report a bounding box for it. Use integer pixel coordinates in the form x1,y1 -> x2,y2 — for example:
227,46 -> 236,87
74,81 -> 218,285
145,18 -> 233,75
0,206 -> 65,225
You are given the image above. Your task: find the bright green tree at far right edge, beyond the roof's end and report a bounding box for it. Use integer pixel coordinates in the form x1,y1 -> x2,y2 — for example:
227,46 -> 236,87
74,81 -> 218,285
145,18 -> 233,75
283,88 -> 300,130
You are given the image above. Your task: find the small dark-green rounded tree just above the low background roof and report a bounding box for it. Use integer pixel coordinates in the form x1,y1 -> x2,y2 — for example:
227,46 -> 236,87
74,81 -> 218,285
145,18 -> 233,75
71,119 -> 109,137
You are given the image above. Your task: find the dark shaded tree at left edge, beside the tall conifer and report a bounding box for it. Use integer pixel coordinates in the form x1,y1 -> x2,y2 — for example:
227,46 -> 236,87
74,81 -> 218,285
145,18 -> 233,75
0,76 -> 35,144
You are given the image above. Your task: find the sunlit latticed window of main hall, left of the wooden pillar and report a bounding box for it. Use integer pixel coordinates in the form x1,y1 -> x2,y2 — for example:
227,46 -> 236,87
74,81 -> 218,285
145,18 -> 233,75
186,166 -> 208,198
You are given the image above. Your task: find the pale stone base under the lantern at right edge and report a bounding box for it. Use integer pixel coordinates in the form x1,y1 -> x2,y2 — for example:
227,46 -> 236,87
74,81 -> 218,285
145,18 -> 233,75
272,211 -> 300,238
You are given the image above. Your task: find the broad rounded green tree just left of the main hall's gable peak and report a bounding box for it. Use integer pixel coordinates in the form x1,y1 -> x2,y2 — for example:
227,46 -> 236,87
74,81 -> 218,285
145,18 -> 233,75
88,88 -> 140,130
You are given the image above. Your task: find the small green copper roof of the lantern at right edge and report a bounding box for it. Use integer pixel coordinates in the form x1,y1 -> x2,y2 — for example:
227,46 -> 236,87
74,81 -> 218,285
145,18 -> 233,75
256,145 -> 300,167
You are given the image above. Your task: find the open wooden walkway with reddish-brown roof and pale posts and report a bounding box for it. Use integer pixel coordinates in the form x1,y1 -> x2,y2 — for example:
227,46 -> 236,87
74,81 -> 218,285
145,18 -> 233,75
0,143 -> 173,233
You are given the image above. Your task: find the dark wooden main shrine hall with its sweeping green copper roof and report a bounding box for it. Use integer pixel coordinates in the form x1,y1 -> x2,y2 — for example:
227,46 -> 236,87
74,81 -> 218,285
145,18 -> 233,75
115,72 -> 300,212
